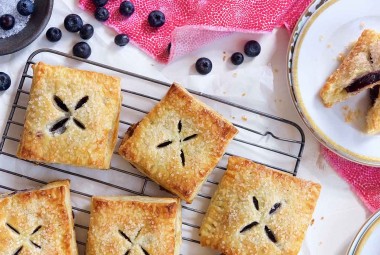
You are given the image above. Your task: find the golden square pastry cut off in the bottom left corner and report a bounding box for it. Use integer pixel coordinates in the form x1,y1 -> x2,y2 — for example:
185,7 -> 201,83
0,180 -> 78,255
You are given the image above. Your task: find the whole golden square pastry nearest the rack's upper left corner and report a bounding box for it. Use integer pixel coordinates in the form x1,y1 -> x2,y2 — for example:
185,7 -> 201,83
17,63 -> 121,169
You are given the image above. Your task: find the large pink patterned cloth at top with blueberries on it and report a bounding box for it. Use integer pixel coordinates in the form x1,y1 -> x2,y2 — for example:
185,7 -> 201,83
79,0 -> 311,63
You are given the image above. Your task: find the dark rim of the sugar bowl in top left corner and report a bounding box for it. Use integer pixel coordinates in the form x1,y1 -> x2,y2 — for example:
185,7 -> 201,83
0,0 -> 54,56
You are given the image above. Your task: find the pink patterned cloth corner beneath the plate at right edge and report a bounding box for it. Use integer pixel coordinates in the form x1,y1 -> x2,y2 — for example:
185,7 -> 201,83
321,147 -> 380,212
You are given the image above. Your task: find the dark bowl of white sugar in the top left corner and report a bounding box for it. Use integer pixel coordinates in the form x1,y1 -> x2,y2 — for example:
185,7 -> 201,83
0,0 -> 54,56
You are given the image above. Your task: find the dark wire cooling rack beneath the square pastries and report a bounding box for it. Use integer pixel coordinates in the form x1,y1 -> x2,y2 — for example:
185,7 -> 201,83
0,49 -> 305,254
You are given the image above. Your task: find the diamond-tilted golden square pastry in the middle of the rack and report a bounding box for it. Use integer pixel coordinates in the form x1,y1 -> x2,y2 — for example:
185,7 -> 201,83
119,84 -> 237,203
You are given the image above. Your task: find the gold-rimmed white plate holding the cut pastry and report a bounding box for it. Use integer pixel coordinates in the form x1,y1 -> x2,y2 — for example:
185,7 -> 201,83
288,0 -> 380,166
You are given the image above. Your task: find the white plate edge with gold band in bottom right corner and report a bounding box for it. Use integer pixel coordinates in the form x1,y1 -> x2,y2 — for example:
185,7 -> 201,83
347,211 -> 380,255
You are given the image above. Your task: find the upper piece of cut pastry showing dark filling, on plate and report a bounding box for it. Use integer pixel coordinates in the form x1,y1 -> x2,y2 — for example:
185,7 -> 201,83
320,30 -> 380,107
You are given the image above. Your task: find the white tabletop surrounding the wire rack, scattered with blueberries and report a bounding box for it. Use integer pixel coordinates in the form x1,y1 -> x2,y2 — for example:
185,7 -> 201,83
0,0 -> 370,255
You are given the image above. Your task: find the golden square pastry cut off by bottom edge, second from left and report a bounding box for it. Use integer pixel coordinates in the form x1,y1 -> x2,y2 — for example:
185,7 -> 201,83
86,196 -> 182,255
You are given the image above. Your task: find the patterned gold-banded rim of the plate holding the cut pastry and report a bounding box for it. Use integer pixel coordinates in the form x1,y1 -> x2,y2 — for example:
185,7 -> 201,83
287,0 -> 380,167
